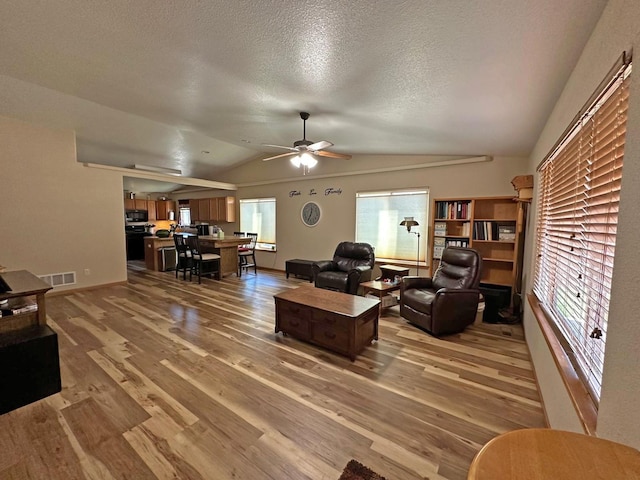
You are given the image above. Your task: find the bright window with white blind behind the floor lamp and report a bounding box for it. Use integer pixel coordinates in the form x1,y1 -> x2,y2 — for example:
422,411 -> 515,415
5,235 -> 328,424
356,189 -> 429,264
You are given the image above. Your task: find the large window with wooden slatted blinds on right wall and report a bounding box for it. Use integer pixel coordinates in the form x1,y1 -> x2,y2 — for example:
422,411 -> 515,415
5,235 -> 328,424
534,56 -> 631,404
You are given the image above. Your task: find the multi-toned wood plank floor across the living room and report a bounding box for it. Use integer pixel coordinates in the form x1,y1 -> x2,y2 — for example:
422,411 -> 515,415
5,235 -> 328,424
0,265 -> 544,480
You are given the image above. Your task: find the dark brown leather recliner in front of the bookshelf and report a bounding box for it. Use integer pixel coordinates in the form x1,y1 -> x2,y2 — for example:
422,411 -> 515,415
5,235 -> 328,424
400,247 -> 482,336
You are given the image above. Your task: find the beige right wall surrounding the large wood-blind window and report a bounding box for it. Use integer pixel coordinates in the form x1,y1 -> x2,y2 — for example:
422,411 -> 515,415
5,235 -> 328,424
524,0 -> 640,448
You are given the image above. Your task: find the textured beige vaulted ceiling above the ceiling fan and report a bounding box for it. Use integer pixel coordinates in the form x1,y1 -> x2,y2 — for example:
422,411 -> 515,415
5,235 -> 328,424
0,0 -> 606,183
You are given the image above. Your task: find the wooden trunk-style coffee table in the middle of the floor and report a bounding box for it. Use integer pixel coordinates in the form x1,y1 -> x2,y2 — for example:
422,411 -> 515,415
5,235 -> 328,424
273,286 -> 380,361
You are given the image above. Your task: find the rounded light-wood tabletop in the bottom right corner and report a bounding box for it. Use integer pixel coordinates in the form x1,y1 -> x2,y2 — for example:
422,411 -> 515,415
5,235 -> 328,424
467,428 -> 640,480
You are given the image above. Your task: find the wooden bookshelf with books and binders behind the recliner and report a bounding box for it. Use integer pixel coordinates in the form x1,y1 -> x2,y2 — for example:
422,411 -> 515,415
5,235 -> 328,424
429,197 -> 524,289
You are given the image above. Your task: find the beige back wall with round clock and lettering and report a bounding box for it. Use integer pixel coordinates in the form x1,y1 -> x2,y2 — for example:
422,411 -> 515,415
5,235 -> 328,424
222,156 -> 528,270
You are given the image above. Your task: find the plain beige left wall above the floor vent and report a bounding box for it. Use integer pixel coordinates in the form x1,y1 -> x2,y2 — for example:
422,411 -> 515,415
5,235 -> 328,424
0,117 -> 126,290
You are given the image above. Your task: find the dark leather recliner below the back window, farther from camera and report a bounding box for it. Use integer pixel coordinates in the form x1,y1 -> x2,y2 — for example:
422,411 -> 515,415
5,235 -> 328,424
311,242 -> 376,295
